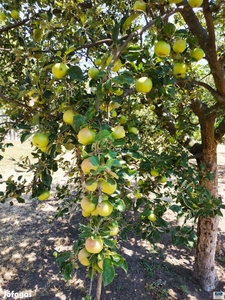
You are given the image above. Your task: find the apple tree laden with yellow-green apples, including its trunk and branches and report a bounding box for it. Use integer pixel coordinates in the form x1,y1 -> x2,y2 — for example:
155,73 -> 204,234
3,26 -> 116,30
0,0 -> 225,299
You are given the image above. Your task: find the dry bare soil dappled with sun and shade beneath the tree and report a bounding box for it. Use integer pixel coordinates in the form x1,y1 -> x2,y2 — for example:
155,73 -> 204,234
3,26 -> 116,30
0,142 -> 225,300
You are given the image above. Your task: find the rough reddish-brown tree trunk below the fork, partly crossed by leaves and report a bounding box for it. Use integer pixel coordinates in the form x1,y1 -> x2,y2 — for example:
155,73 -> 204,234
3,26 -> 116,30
194,126 -> 219,292
